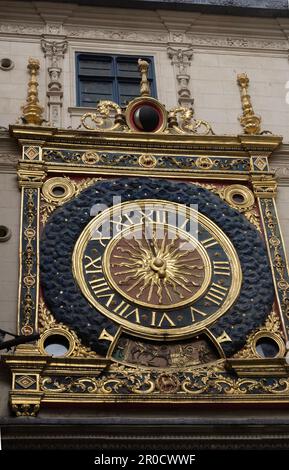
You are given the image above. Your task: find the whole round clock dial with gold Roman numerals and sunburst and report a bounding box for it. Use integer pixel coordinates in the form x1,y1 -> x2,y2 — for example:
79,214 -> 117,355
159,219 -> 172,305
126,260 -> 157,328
73,200 -> 242,339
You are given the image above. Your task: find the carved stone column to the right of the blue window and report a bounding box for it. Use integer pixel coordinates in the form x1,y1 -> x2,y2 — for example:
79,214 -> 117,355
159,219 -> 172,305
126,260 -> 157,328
167,47 -> 194,108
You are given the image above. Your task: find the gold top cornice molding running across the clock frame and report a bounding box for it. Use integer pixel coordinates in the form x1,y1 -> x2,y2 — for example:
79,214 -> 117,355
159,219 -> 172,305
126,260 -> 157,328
10,125 -> 282,156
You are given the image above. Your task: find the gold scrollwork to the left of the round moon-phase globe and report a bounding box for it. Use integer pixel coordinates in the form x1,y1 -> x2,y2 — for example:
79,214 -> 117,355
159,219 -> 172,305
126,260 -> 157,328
81,100 -> 124,131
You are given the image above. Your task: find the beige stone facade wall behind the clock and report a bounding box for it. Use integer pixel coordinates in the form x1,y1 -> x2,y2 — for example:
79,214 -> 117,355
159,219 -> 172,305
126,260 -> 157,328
0,1 -> 289,416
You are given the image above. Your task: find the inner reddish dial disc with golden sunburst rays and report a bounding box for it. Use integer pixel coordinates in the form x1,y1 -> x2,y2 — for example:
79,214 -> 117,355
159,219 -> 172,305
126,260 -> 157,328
103,221 -> 211,309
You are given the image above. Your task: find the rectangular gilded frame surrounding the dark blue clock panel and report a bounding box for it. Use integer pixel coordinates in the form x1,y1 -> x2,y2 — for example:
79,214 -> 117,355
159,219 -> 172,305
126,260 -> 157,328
4,126 -> 289,416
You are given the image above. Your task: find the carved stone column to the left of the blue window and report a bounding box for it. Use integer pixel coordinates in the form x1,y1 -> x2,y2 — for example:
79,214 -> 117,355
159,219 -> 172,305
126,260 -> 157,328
41,39 -> 68,127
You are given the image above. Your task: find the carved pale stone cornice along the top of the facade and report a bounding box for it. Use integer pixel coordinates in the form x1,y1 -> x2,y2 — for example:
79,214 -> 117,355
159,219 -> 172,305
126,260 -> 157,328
0,2 -> 289,53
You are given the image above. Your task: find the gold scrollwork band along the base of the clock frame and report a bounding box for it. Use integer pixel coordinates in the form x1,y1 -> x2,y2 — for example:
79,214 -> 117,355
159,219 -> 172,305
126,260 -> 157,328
40,361 -> 289,401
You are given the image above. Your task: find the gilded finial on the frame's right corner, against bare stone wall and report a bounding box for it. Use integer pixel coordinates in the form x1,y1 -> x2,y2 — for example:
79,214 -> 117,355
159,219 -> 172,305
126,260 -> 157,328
237,73 -> 261,134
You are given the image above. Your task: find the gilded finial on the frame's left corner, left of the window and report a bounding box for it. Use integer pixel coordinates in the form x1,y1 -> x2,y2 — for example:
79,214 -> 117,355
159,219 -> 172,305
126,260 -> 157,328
21,58 -> 44,126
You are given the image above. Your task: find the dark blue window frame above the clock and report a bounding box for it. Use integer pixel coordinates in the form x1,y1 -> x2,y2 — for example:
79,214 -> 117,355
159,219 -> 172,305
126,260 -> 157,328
75,52 -> 157,108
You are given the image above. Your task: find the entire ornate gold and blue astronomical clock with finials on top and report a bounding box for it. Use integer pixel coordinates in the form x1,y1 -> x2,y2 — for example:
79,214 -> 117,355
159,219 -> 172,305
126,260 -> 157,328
6,60 -> 289,415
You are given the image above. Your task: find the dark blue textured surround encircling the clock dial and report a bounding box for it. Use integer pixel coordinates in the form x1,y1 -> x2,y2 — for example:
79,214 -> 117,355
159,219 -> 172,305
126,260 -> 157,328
40,178 -> 274,356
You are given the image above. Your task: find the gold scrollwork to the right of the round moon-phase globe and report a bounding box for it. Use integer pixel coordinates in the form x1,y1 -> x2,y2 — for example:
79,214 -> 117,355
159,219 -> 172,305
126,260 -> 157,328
168,106 -> 214,135
